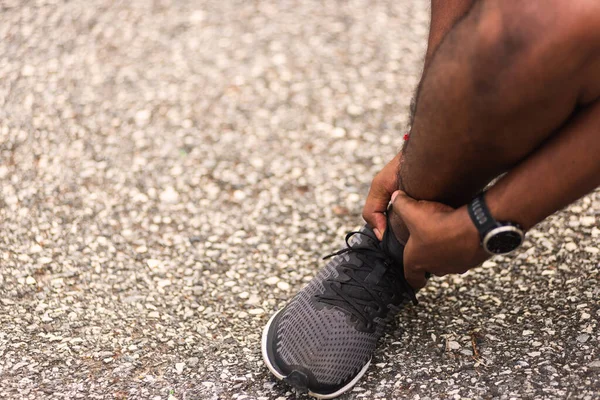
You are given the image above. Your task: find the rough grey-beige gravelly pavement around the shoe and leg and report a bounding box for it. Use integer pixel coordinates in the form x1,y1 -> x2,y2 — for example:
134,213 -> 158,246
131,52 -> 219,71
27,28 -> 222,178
0,0 -> 600,400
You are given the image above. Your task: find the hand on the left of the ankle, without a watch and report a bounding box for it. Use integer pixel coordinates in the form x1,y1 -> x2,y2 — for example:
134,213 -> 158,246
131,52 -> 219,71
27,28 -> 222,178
363,153 -> 402,240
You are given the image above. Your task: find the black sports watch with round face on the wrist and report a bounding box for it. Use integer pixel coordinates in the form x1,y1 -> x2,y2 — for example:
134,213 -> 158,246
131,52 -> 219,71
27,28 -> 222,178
467,193 -> 525,255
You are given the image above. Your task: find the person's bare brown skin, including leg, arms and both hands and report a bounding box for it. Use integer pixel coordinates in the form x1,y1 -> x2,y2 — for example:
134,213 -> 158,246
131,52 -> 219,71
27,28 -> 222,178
363,0 -> 600,288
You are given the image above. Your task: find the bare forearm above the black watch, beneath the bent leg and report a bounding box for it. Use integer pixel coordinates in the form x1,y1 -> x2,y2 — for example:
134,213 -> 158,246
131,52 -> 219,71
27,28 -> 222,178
486,102 -> 600,229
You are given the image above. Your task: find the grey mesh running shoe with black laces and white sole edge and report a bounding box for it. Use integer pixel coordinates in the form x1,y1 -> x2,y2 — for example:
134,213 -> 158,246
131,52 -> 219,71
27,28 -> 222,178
262,220 -> 416,399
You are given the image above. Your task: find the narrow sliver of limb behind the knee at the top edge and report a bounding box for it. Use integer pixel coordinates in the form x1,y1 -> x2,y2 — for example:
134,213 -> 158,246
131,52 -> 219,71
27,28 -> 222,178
425,0 -> 474,65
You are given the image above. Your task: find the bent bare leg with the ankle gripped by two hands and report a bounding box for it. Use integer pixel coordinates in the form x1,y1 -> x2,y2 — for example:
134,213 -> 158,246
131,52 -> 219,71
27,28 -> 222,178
392,0 -> 600,239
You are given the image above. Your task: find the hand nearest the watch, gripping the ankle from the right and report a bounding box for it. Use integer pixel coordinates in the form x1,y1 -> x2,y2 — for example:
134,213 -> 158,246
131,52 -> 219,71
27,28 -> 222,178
392,190 -> 490,289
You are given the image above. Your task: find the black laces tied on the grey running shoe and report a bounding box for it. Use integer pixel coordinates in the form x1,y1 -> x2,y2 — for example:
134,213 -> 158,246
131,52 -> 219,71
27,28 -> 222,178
317,231 -> 418,329
